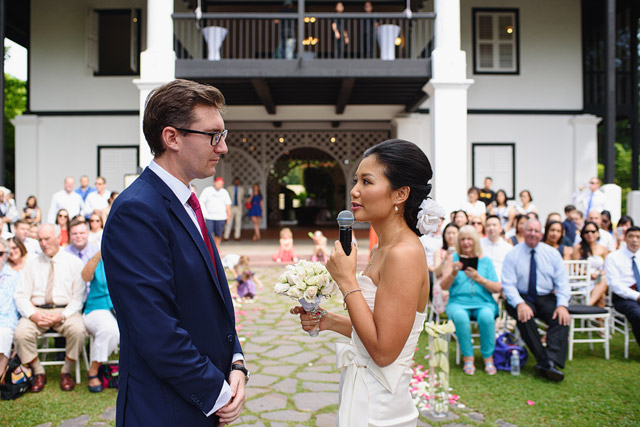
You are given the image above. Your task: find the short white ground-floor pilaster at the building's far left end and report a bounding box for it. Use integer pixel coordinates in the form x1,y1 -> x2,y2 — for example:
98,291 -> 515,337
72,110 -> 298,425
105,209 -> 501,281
11,114 -> 39,207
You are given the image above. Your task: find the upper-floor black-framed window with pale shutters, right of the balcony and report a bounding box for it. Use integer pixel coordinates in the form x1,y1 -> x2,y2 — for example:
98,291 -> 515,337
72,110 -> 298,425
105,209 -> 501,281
473,9 -> 520,74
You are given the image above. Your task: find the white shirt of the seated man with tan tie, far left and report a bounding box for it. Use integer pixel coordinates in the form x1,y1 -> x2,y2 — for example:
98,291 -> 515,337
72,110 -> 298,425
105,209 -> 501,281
14,248 -> 87,318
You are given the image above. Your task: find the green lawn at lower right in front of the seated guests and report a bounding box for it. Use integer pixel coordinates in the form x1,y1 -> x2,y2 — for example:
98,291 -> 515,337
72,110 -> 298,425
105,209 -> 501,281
415,333 -> 640,426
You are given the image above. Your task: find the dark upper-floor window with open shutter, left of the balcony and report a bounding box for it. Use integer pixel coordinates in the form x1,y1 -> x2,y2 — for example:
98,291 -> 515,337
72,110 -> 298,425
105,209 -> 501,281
87,9 -> 141,76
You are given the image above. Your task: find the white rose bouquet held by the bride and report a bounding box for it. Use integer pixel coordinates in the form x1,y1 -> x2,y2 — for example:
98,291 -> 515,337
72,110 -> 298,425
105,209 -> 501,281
273,260 -> 338,337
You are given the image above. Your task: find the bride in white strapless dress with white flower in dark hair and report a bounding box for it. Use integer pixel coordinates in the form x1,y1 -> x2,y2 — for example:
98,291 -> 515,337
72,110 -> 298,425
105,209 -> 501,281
291,139 -> 442,427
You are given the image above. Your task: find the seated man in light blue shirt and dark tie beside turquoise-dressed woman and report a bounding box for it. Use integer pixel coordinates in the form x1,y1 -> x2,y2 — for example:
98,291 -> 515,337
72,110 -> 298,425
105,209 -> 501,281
502,219 -> 571,381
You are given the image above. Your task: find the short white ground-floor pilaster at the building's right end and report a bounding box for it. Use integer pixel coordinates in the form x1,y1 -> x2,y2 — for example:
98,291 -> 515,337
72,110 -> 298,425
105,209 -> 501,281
570,114 -> 602,190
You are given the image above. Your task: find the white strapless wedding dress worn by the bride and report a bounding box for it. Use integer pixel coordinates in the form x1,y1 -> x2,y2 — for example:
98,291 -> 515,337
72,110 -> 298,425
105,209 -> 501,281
336,275 -> 427,427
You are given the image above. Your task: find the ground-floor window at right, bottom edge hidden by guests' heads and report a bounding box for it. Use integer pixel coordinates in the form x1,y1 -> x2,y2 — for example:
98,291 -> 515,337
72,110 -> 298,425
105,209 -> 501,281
471,143 -> 516,199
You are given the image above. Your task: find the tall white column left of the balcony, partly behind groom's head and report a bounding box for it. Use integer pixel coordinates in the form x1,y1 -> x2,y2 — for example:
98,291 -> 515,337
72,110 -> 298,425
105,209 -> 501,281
133,0 -> 176,167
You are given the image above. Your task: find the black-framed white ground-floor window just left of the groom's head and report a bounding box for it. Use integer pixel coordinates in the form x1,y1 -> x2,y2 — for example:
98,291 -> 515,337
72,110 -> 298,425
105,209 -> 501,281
98,145 -> 140,191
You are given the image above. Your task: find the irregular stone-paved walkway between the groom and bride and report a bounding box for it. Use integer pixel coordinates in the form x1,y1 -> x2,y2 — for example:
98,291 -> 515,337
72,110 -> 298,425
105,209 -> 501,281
40,241 -> 509,427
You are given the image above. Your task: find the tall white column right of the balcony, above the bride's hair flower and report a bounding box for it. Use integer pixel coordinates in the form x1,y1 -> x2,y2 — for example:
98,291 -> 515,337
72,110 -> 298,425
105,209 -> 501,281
425,0 -> 473,212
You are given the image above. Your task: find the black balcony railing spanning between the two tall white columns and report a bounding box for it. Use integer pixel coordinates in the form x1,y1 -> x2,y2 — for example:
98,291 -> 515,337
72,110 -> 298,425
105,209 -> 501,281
173,13 -> 435,60
